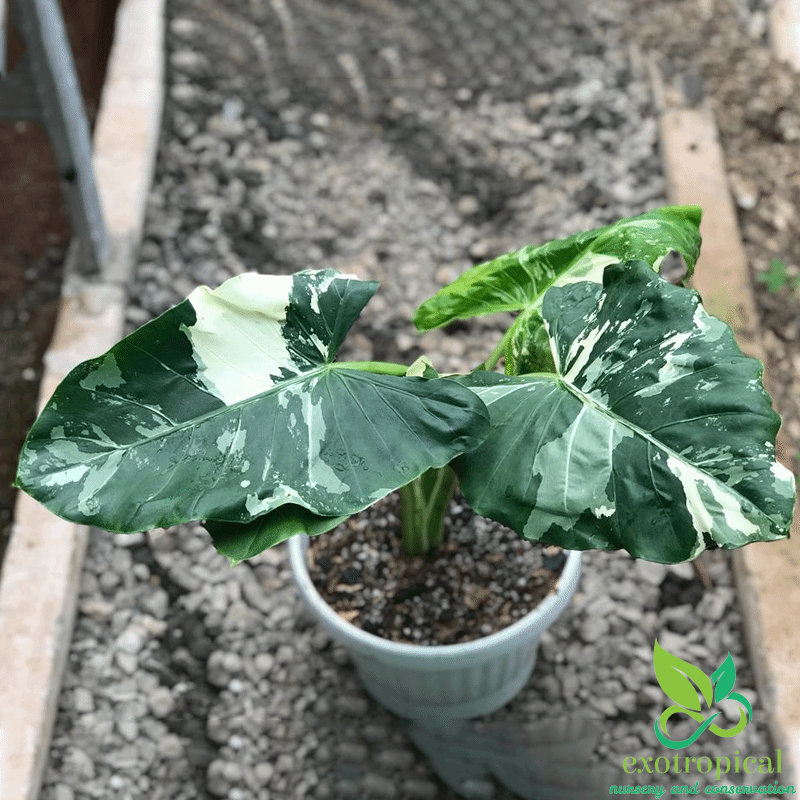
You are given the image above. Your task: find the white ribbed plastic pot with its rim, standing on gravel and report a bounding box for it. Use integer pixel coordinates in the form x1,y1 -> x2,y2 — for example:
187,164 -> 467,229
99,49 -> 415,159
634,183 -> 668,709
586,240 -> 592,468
289,535 -> 581,719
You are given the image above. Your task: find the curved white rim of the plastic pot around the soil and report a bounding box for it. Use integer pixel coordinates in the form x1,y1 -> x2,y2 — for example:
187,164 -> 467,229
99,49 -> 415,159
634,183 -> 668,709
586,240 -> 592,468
288,534 -> 581,662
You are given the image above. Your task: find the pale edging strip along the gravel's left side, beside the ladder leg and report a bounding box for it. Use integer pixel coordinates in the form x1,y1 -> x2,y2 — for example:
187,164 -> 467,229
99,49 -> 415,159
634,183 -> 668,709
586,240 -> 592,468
0,0 -> 165,800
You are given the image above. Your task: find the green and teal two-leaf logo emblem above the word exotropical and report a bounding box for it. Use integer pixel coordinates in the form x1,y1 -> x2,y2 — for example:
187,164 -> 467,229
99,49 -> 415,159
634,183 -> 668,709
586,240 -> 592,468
653,639 -> 753,750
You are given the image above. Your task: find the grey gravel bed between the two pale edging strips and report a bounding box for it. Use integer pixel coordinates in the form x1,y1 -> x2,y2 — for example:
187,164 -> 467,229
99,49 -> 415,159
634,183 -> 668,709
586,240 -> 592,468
40,0 -> 771,800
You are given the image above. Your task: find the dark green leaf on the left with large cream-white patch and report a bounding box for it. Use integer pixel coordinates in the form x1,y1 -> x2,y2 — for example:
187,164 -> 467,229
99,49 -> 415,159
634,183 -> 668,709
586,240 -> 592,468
16,270 -> 488,532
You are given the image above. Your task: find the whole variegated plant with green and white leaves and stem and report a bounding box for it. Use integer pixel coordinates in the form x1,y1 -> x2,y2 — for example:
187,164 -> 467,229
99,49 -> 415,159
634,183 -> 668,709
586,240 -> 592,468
16,207 -> 794,563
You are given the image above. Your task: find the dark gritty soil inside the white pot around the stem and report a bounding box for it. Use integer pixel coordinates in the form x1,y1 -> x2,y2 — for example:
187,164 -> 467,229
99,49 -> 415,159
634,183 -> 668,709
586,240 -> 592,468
308,494 -> 566,645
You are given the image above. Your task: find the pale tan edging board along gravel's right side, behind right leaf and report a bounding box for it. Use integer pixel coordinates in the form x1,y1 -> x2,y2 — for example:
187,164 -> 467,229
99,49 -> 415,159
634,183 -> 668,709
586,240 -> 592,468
661,103 -> 800,784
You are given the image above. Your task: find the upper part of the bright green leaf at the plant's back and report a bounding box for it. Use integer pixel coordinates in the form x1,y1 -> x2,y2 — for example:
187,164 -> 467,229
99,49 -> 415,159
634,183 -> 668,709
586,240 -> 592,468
414,206 -> 701,331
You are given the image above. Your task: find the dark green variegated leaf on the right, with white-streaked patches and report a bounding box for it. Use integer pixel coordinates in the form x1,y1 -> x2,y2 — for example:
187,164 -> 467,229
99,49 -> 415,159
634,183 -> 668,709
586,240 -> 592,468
453,262 -> 794,563
